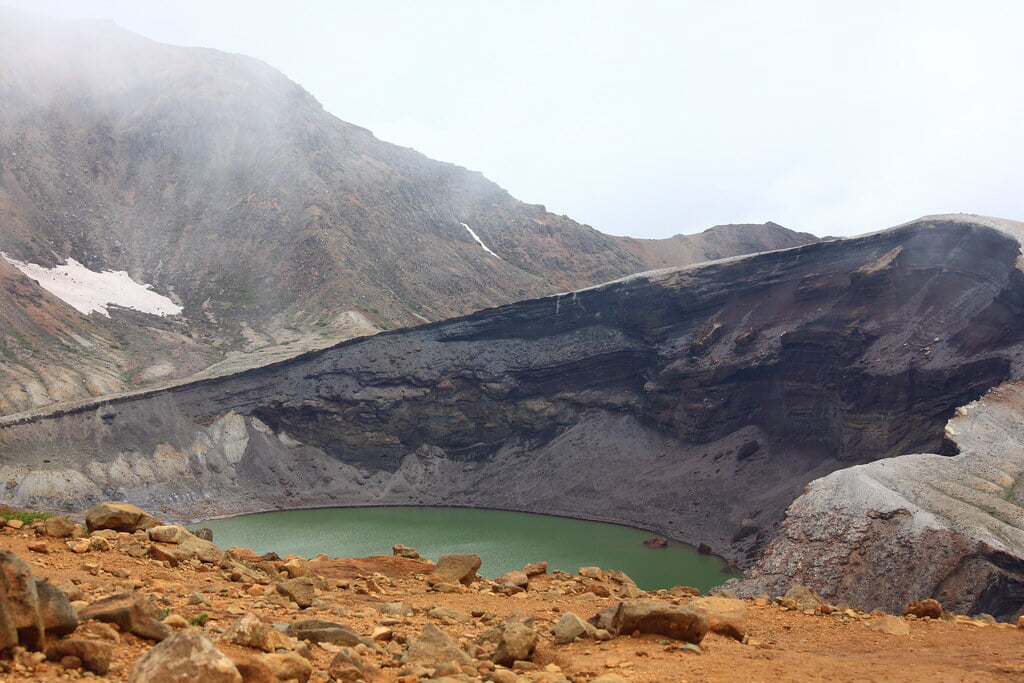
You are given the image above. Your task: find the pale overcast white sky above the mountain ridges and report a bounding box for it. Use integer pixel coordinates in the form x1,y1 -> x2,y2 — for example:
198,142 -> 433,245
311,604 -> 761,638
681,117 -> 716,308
0,0 -> 1024,237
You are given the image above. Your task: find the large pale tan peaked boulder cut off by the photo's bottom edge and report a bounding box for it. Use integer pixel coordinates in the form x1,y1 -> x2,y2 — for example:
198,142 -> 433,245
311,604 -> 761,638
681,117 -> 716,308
128,631 -> 239,683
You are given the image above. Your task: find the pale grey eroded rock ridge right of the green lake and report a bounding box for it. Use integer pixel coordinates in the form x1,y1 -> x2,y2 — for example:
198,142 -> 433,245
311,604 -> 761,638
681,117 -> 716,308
730,382 -> 1024,618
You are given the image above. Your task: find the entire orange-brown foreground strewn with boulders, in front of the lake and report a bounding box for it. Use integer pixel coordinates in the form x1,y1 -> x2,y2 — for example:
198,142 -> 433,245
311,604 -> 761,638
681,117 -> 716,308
0,504 -> 1024,683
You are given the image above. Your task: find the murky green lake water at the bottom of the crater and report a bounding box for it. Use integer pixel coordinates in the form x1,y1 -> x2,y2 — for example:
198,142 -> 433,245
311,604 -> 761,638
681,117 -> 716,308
196,507 -> 734,591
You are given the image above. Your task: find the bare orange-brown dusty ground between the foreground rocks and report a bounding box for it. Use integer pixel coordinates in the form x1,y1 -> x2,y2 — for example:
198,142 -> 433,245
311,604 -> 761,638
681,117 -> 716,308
0,528 -> 1024,681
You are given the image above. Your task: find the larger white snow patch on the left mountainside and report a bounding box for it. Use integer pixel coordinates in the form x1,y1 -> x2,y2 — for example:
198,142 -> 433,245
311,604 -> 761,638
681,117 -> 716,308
0,252 -> 182,317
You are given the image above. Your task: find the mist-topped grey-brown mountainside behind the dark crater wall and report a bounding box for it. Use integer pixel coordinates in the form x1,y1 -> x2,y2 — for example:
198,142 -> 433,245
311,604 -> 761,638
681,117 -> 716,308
0,8 -> 815,413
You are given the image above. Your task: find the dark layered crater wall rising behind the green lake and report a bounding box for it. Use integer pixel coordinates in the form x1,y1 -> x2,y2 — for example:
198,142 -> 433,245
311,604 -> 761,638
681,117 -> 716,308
0,216 -> 1024,577
